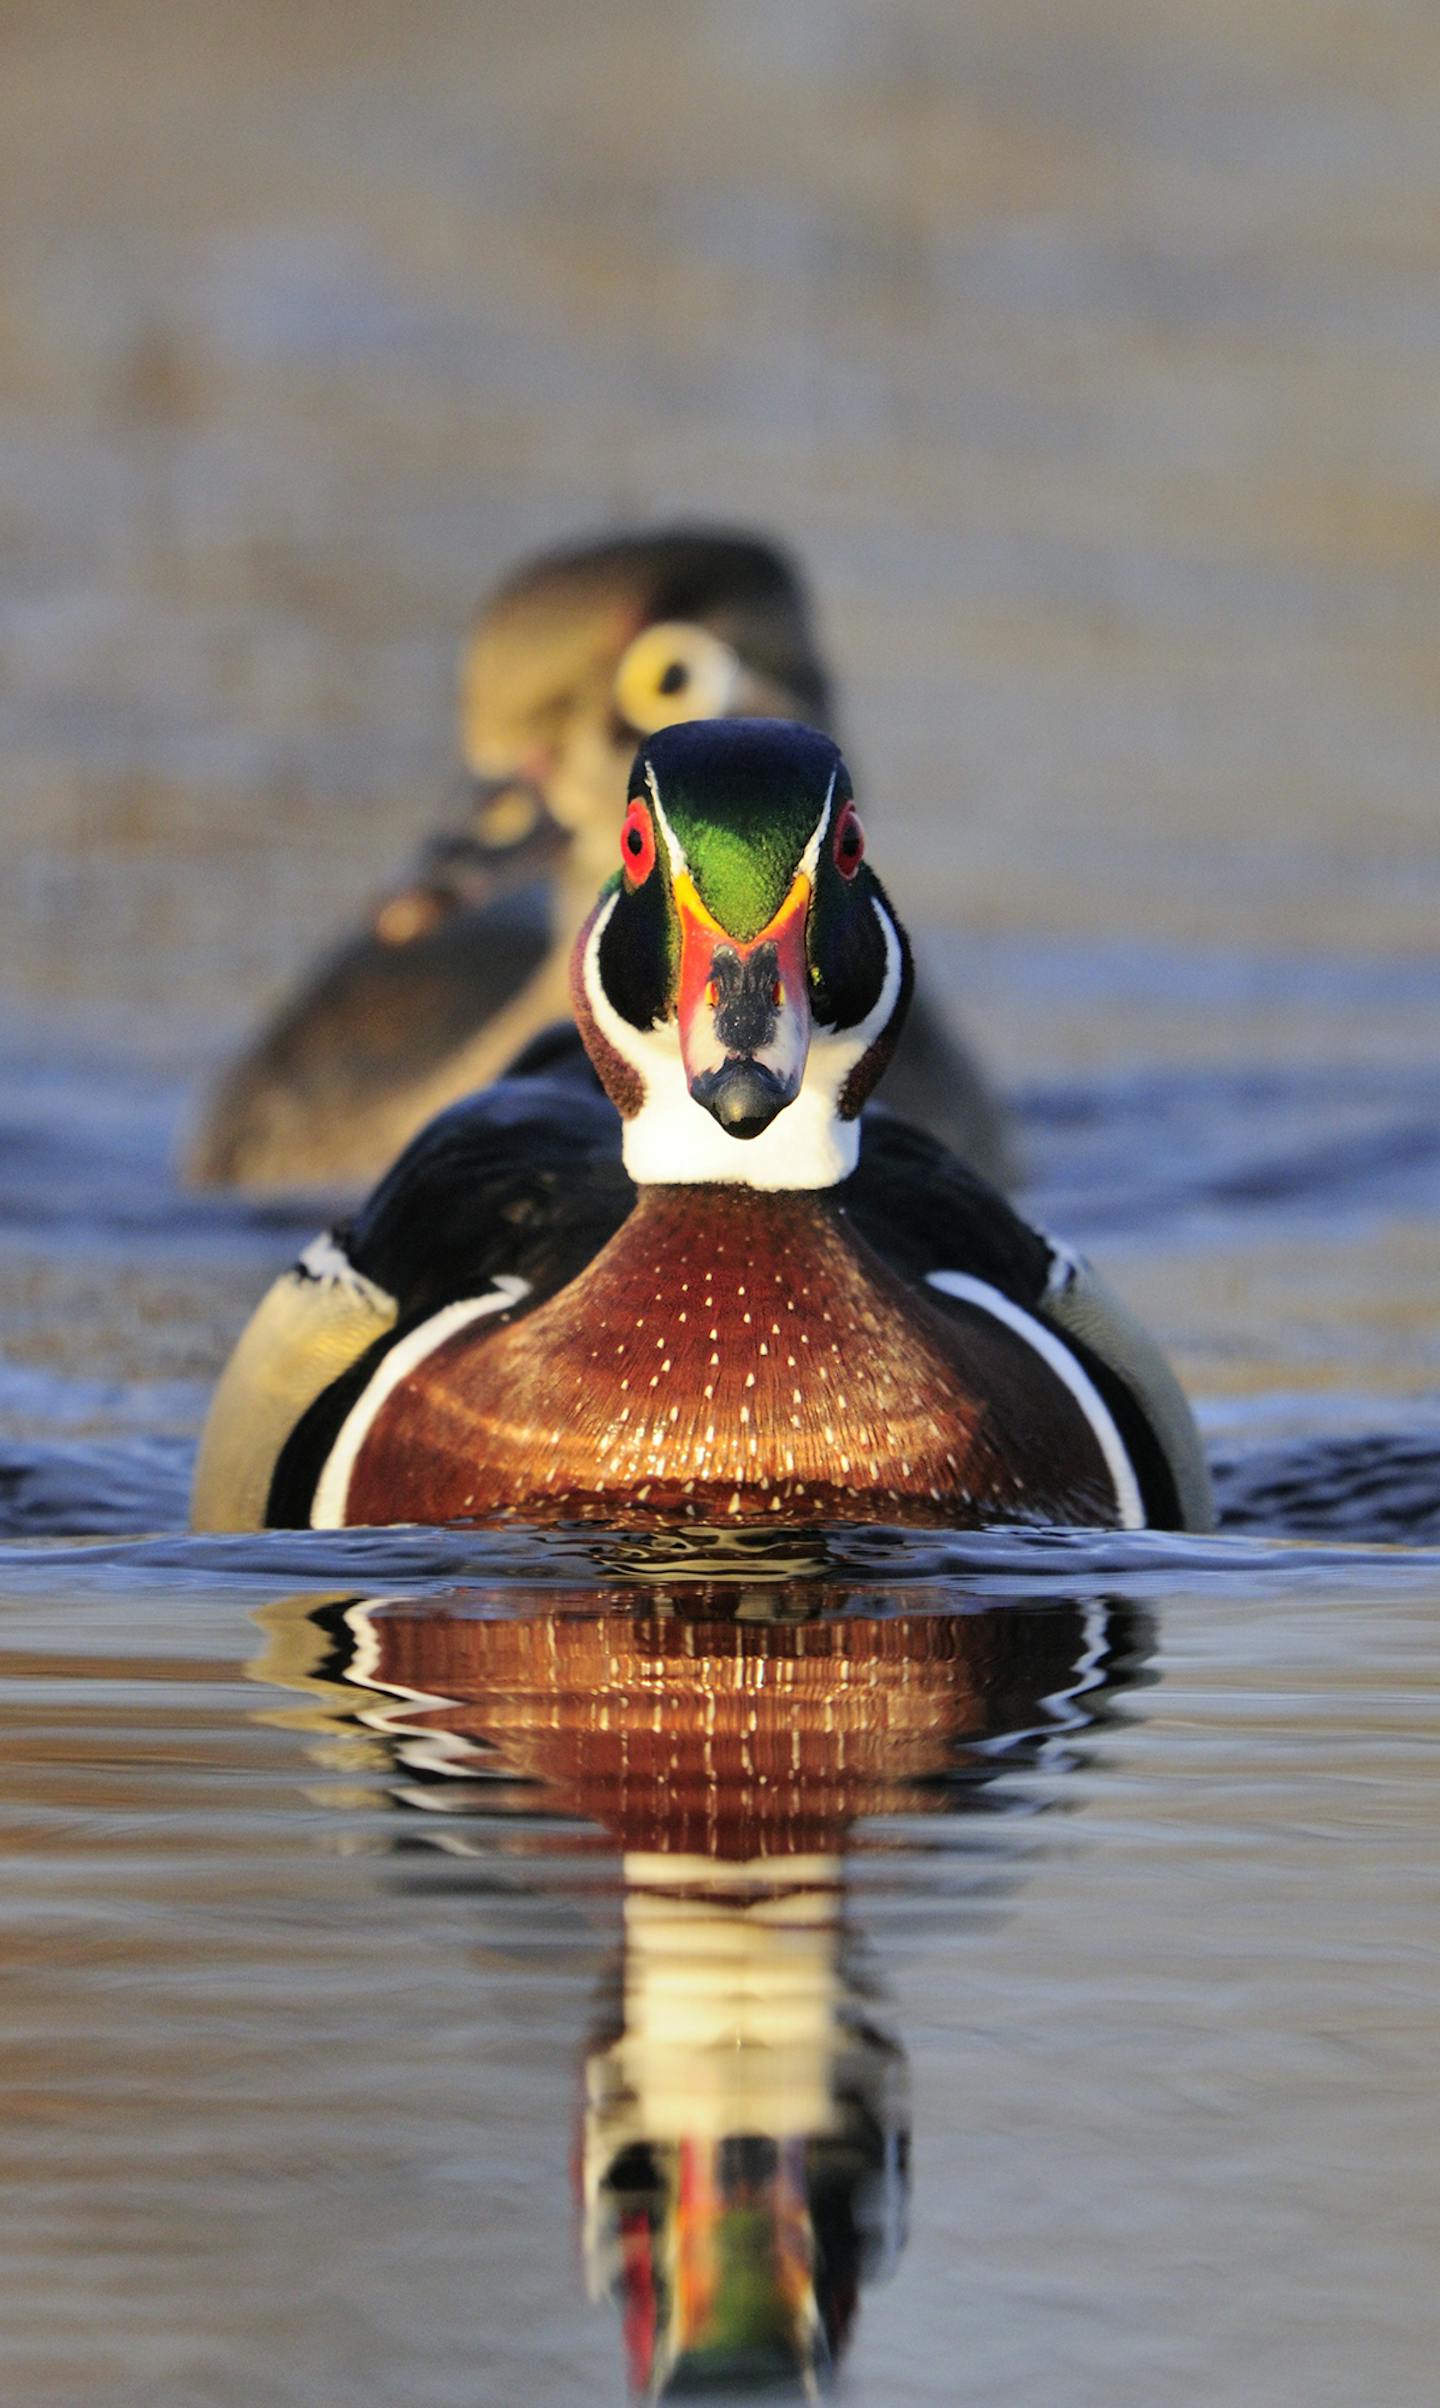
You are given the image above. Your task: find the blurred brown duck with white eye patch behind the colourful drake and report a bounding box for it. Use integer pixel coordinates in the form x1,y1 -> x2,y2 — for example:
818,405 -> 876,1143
185,527 -> 1009,1192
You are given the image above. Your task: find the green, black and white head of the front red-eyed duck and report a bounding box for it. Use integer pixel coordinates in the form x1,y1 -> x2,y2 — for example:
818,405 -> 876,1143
573,720 -> 910,1190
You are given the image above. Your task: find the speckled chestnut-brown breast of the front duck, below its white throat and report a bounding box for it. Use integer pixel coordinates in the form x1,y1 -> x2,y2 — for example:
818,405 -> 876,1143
344,1187 -> 1117,1524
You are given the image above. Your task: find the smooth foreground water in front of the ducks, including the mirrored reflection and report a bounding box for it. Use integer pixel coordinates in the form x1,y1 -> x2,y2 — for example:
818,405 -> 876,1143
0,1534 -> 1440,2408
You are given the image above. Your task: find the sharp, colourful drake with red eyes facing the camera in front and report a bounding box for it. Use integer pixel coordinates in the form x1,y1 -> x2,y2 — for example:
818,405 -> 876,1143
195,720 -> 1209,1529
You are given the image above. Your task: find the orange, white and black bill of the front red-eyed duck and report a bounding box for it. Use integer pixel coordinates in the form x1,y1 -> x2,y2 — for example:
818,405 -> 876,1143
674,872 -> 812,1139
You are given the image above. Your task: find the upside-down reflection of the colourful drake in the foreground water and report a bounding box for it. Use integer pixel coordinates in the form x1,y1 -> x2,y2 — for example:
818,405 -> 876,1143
253,1550 -> 1146,2401
